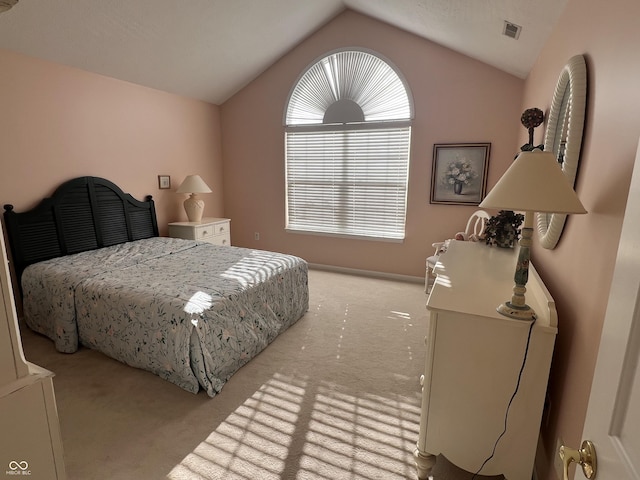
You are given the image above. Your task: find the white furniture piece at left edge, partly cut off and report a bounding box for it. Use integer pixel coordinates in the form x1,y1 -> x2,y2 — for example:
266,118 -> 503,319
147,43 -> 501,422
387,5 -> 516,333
0,223 -> 66,480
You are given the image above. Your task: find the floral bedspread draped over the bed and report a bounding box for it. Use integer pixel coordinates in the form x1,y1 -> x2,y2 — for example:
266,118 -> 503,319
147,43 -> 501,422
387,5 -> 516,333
22,237 -> 309,396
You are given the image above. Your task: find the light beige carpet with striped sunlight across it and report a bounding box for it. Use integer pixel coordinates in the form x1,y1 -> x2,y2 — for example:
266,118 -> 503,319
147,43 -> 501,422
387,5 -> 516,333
22,270 -> 427,480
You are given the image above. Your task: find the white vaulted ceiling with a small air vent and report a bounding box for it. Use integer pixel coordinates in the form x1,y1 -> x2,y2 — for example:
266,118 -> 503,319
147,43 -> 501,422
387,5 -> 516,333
0,0 -> 567,104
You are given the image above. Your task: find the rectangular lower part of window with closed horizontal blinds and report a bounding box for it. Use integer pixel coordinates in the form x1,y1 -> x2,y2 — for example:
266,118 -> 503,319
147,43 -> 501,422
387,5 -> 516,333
286,126 -> 411,240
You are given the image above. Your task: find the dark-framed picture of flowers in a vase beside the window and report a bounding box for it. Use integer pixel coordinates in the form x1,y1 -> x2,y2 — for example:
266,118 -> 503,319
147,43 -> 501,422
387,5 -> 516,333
431,143 -> 491,205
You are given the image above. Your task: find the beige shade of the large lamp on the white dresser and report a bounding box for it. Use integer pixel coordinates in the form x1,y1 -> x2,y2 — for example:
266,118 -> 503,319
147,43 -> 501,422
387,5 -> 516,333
480,150 -> 587,213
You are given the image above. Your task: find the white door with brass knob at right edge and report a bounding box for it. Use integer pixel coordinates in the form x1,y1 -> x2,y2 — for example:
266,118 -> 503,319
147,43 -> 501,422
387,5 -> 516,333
569,137 -> 640,480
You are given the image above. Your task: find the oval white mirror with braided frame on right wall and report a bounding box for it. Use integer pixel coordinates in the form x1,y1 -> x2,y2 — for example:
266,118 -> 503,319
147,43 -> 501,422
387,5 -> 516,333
537,55 -> 587,249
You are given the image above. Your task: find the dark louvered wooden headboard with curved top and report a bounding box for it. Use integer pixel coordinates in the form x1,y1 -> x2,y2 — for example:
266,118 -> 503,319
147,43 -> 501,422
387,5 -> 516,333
4,177 -> 158,281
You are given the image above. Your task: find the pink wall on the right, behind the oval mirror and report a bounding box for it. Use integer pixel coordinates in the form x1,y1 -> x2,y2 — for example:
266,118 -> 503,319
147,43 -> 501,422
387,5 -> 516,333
524,0 -> 640,478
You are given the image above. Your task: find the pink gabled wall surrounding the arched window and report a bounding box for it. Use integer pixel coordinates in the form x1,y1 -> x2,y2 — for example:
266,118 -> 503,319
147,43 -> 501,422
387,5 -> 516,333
221,11 -> 525,276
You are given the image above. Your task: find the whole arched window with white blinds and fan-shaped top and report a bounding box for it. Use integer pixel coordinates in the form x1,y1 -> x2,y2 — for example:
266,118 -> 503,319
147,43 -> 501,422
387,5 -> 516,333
285,50 -> 413,240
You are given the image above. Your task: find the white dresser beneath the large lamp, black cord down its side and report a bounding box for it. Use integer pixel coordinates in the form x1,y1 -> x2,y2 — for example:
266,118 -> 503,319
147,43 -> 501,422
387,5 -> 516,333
415,241 -> 557,480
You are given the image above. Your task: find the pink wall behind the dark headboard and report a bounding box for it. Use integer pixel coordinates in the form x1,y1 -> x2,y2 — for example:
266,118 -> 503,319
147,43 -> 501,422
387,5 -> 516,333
0,50 -> 223,233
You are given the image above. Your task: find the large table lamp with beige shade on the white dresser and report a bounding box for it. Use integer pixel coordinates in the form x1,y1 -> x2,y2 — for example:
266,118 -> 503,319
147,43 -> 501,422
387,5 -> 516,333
480,149 -> 587,320
